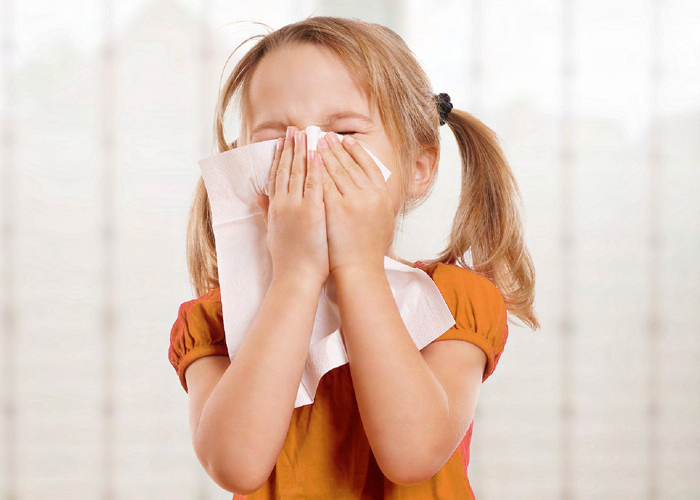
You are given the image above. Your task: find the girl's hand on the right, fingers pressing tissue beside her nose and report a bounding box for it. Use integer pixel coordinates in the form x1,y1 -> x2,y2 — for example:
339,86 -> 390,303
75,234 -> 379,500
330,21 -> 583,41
317,132 -> 394,275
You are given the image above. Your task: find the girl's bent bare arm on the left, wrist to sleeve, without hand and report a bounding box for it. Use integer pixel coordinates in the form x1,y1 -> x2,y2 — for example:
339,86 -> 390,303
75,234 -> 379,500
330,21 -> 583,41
185,274 -> 323,495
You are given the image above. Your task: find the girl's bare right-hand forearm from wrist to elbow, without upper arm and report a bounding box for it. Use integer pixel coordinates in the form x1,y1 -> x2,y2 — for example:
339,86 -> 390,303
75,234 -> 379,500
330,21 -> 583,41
334,267 -> 449,480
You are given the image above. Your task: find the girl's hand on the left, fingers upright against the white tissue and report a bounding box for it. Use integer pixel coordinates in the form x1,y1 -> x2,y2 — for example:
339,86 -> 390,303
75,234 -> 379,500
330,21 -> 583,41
255,127 -> 330,284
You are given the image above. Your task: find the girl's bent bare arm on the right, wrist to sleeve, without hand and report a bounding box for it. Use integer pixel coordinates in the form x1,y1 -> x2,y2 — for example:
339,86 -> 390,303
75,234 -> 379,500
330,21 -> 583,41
334,266 -> 486,485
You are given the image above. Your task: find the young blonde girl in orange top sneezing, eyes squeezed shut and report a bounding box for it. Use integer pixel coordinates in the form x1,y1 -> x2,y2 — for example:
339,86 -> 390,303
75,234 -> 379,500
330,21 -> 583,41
168,17 -> 539,500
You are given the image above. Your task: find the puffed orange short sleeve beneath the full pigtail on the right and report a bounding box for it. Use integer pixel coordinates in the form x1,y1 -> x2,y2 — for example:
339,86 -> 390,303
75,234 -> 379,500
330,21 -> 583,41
426,262 -> 508,383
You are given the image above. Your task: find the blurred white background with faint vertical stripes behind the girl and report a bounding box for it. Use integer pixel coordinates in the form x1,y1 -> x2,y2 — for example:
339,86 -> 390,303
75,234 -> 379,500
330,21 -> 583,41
0,0 -> 700,500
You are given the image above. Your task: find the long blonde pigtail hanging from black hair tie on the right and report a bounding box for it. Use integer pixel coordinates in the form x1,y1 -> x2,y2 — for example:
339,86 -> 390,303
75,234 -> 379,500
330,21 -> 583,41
435,109 -> 540,330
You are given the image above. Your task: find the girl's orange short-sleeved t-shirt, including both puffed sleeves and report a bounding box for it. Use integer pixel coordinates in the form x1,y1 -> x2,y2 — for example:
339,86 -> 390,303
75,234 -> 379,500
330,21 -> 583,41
168,261 -> 508,500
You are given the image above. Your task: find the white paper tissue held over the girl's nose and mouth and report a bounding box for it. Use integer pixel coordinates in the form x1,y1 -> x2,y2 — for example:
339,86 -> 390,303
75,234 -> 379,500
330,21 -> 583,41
199,125 -> 455,408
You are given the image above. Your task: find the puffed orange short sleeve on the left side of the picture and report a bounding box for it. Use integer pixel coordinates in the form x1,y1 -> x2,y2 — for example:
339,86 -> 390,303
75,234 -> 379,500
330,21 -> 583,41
168,288 -> 228,392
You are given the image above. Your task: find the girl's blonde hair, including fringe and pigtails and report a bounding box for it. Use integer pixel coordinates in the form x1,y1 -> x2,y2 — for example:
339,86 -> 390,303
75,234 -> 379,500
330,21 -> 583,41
187,16 -> 540,330
